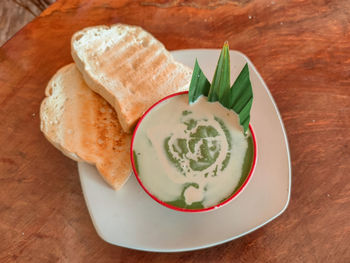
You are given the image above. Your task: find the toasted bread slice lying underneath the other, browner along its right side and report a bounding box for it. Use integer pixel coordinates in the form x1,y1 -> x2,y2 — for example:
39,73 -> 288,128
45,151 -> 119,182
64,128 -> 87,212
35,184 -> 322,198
40,64 -> 131,189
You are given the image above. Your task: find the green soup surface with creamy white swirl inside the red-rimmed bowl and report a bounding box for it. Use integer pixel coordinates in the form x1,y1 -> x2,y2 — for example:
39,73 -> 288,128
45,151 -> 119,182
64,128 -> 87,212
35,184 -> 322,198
133,94 -> 252,209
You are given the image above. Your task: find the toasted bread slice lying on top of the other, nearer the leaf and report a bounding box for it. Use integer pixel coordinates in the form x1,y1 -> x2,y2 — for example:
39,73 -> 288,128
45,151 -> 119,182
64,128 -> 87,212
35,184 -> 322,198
71,24 -> 192,132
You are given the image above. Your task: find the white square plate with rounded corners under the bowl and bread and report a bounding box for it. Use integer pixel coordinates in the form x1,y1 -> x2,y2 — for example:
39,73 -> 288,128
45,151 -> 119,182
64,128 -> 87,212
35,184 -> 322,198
78,49 -> 291,252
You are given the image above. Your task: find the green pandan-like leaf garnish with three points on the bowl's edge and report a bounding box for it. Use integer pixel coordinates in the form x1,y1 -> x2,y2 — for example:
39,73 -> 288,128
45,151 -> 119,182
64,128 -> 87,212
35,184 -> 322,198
188,42 -> 253,133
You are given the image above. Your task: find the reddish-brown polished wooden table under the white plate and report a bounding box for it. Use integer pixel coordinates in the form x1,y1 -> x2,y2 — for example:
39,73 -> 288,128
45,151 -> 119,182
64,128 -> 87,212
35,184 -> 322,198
0,0 -> 350,262
